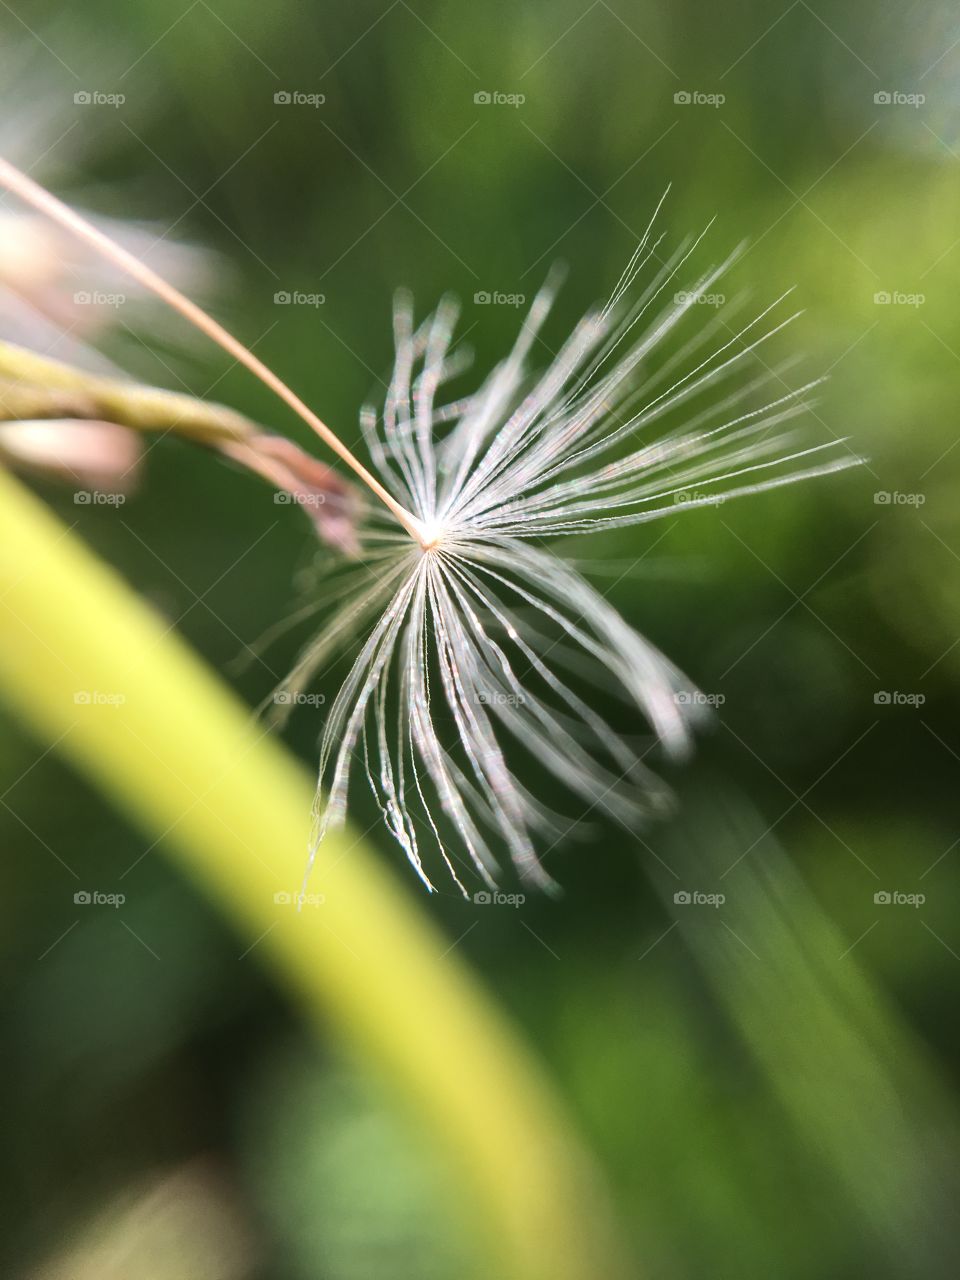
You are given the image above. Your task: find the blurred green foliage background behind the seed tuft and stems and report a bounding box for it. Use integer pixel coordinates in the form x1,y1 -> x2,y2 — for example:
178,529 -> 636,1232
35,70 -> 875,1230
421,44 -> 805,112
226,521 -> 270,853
0,0 -> 960,1280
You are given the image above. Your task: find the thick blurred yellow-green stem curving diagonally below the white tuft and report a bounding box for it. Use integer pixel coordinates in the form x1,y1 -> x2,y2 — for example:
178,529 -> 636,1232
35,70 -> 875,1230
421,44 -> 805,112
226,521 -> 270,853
0,472 -> 632,1280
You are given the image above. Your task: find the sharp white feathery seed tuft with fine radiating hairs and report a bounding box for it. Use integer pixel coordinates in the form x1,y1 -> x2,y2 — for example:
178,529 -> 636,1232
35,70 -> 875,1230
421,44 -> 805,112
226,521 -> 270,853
285,207 -> 859,893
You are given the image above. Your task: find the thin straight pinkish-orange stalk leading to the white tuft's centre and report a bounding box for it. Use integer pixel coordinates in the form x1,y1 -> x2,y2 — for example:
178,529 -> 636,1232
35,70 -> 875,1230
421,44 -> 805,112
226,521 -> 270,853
0,156 -> 426,547
